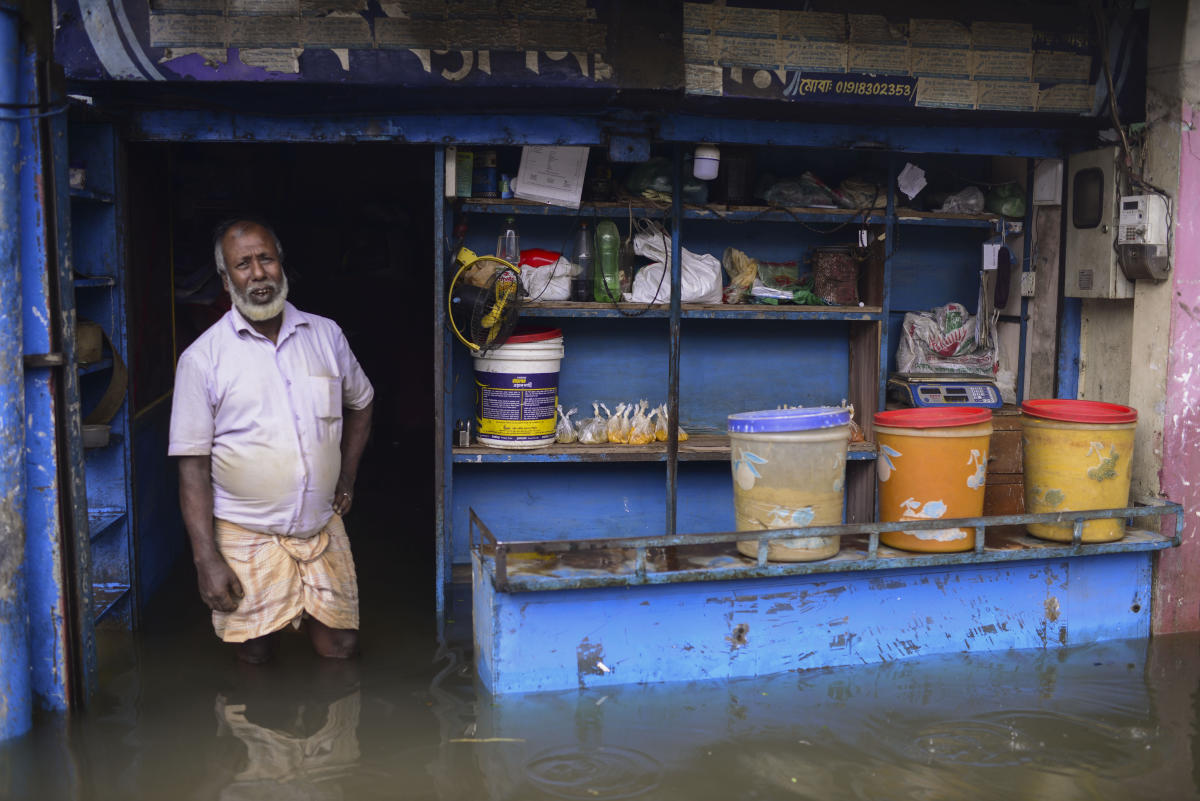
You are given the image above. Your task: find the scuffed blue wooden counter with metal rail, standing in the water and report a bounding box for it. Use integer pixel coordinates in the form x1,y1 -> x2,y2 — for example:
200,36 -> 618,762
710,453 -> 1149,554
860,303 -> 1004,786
473,505 -> 1178,695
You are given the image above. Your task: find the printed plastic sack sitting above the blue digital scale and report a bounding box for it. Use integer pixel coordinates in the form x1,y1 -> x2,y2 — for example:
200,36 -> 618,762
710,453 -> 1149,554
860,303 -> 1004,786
896,303 -> 997,375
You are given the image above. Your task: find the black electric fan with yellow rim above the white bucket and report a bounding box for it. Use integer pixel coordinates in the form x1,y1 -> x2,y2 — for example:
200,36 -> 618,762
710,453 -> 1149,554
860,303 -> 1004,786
446,248 -> 523,355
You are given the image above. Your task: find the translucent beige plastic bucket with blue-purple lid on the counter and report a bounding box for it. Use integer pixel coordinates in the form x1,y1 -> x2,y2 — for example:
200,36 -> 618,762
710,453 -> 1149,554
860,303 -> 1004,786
730,406 -> 850,562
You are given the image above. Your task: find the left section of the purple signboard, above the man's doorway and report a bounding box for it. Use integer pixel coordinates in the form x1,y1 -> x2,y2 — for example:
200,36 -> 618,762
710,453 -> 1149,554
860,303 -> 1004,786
55,0 -> 616,88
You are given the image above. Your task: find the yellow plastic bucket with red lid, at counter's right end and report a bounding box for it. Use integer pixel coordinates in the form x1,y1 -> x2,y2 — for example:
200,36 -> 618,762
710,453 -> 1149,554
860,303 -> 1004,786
1021,399 -> 1138,542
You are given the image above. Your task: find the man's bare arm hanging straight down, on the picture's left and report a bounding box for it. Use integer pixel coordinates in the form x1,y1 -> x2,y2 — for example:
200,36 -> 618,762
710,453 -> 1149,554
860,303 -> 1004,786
179,456 -> 242,612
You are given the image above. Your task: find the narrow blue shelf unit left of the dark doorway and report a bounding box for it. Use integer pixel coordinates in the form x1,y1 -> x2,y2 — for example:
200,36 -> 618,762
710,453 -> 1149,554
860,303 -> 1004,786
67,119 -> 137,633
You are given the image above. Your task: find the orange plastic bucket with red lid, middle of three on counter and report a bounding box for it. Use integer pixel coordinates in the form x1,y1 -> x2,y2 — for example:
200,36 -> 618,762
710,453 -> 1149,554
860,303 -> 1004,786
875,406 -> 991,553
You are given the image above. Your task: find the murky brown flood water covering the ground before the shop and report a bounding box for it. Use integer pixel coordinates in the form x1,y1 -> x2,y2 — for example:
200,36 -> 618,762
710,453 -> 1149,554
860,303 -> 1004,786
7,482 -> 1200,801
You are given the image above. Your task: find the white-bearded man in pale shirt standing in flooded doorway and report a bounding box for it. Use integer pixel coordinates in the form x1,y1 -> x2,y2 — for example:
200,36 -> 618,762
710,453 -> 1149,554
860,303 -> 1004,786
169,219 -> 374,663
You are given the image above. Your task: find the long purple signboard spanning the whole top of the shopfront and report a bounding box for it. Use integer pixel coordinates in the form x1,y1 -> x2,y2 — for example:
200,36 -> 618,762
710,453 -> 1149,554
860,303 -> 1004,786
55,0 -> 1146,122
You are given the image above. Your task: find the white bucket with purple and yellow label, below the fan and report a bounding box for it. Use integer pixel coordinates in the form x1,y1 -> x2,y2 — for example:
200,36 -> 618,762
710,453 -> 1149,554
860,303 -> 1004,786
475,329 -> 563,448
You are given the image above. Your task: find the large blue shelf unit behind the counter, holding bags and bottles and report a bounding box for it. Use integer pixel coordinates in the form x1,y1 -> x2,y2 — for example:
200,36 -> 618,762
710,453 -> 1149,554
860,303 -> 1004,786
434,145 -> 1010,618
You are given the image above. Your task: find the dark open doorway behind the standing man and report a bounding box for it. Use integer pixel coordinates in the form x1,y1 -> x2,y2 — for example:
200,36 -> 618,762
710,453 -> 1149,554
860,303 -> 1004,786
126,143 -> 434,618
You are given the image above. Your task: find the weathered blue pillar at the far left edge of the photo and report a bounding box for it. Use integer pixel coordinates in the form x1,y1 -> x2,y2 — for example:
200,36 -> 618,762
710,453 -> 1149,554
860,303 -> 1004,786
0,8 -> 32,740
